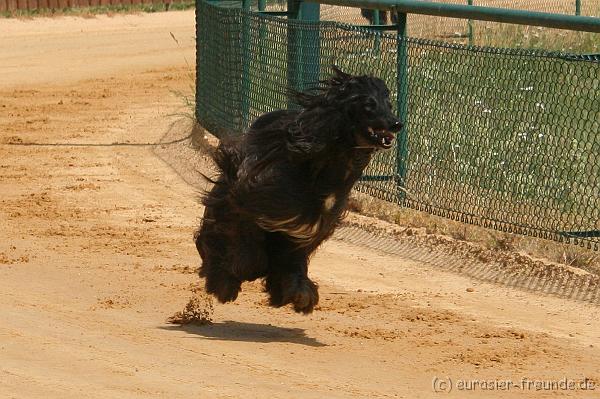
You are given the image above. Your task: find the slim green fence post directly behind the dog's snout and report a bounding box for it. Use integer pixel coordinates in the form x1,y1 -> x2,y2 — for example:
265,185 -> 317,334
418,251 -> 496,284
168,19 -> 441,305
396,12 -> 408,200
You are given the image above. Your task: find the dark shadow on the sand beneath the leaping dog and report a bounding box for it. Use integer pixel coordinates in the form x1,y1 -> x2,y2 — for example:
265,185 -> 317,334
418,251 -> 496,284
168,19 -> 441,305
162,320 -> 327,347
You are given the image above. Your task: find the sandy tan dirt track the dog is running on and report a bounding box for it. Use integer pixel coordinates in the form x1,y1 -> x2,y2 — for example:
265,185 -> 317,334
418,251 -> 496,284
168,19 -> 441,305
0,11 -> 600,398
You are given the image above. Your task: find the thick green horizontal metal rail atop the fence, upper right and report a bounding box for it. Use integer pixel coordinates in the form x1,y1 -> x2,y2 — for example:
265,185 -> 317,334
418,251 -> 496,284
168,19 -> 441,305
306,0 -> 600,33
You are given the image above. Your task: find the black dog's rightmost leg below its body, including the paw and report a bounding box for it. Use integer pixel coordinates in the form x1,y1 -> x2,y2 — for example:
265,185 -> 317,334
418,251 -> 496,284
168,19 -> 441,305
265,233 -> 319,314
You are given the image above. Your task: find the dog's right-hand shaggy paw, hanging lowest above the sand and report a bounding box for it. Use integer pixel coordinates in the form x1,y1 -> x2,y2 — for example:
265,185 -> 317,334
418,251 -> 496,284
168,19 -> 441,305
267,274 -> 319,314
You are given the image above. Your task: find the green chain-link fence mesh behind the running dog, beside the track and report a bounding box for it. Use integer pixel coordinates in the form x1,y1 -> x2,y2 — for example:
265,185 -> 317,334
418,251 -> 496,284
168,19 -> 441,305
196,0 -> 600,249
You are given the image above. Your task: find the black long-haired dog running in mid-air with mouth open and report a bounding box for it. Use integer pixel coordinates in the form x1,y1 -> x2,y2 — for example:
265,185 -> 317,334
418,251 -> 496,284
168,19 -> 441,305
195,68 -> 402,313
